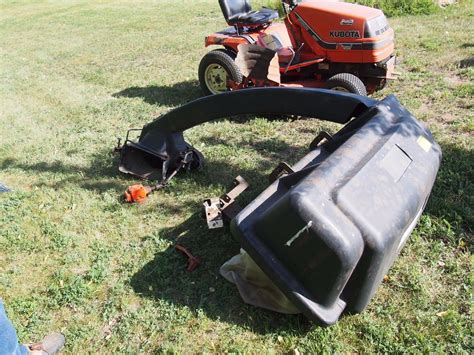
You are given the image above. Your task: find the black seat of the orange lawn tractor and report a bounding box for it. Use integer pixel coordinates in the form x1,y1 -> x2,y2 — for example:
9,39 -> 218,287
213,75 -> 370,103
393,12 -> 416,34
219,0 -> 278,26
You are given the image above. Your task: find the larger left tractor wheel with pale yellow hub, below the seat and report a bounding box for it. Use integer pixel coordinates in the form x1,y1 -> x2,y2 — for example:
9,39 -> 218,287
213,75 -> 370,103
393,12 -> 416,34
199,49 -> 242,95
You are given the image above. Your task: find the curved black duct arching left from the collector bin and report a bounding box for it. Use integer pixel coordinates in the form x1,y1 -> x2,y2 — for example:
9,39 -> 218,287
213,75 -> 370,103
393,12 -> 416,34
119,87 -> 377,179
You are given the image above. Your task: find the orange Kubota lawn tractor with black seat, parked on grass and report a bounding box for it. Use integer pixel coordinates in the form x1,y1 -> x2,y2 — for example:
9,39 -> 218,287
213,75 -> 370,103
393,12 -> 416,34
199,0 -> 395,95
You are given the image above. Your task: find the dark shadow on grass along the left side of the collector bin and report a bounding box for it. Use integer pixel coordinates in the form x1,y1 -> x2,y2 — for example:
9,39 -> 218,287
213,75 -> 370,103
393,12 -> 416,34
130,137 -> 312,334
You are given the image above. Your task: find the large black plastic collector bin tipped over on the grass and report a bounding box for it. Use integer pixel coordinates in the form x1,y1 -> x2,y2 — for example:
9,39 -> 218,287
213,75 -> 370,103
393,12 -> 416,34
231,96 -> 441,325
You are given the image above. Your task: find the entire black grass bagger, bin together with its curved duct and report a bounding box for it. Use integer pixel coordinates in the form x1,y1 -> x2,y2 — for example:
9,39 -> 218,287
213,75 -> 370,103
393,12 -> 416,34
116,88 -> 441,325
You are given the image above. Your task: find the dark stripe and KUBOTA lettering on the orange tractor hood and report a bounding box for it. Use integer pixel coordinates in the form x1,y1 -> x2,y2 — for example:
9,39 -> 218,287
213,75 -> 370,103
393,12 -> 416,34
295,13 -> 393,50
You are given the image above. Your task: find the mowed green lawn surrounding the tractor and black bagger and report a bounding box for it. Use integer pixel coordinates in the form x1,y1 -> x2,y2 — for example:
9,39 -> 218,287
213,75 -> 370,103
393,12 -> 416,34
0,0 -> 474,353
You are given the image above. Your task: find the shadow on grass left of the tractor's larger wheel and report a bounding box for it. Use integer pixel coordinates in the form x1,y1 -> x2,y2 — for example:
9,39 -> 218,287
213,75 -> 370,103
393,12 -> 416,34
112,80 -> 203,106
